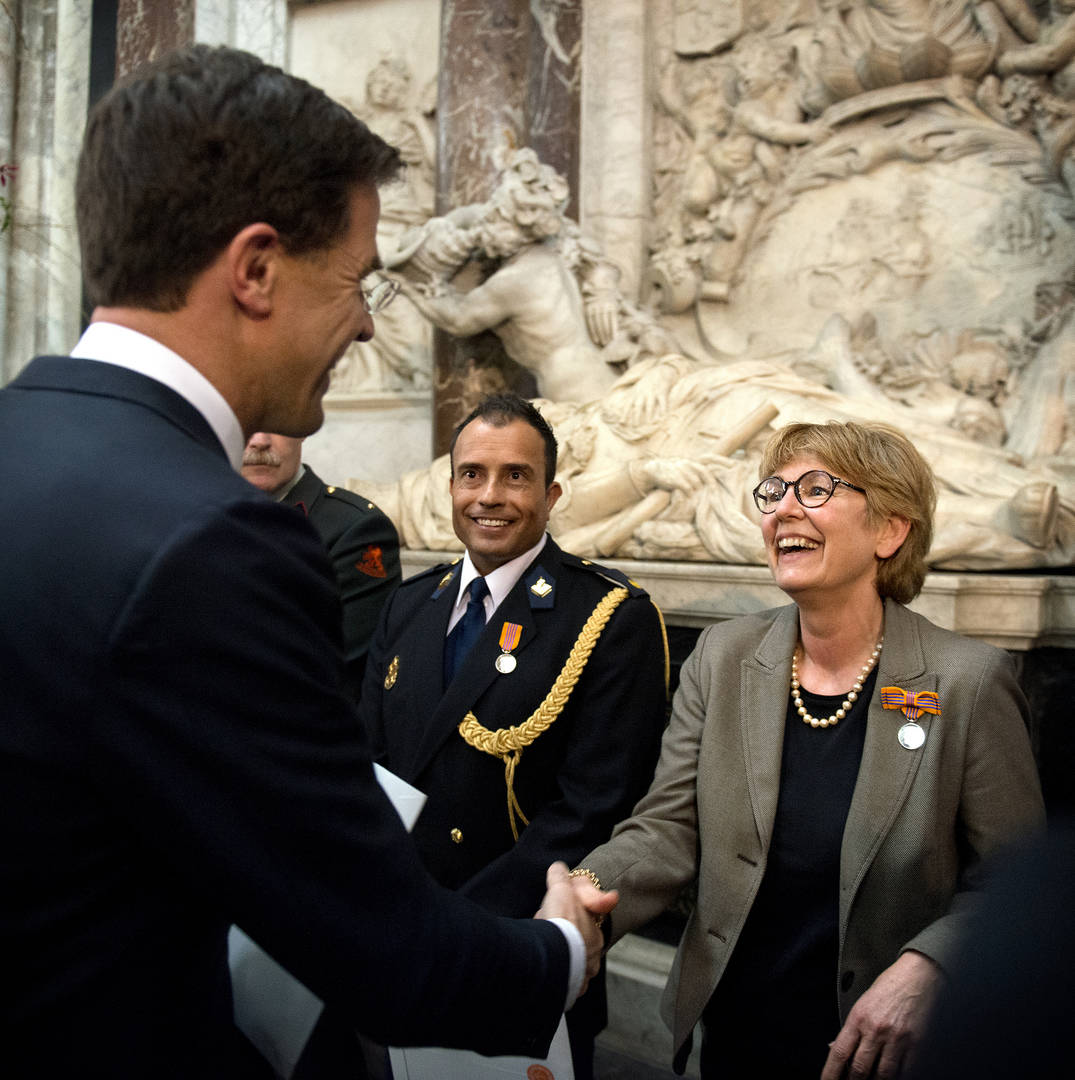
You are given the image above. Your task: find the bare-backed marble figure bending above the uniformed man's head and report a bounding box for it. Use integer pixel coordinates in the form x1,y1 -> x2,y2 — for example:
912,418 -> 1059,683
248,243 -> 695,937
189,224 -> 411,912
382,150 -> 671,401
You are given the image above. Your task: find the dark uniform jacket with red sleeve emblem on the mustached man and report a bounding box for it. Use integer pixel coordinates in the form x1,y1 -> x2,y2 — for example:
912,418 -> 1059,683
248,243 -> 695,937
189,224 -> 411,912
280,465 -> 403,700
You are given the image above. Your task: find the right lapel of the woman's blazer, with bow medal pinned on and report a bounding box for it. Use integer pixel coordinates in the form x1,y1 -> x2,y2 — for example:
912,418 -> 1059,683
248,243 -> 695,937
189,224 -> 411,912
839,600 -> 938,898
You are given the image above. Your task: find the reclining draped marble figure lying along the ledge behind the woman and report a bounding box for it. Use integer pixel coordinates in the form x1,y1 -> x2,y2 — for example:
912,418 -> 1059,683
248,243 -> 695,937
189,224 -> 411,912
348,354 -> 1075,569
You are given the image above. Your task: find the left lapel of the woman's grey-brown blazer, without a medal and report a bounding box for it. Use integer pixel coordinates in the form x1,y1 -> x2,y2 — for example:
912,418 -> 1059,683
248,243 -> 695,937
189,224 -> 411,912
740,605 -> 798,851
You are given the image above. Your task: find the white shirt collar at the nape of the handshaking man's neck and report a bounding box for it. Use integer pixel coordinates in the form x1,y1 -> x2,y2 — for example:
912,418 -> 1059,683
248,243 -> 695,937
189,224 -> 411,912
71,323 -> 246,472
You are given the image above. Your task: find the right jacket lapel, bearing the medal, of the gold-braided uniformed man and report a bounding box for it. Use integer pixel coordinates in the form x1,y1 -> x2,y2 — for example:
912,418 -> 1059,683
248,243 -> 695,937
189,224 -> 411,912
414,539 -> 560,775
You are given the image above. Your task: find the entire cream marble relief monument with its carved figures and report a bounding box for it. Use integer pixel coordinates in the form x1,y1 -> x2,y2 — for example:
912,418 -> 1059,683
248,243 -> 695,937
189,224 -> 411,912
359,0 -> 1075,569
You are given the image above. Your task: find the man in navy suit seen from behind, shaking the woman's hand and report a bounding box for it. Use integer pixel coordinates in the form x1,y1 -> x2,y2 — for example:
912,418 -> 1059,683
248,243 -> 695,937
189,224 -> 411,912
0,45 -> 601,1080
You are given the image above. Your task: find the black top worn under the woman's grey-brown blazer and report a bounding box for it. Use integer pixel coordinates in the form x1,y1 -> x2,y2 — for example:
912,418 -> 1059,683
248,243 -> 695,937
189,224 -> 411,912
702,667 -> 877,1080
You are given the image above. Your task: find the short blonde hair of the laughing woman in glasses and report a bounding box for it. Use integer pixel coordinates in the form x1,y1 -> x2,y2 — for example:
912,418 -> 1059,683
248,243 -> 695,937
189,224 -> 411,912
761,420 -> 937,604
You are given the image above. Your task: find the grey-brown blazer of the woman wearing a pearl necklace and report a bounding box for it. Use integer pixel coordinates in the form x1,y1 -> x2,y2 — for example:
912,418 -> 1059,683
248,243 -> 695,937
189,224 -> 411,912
581,600 -> 1045,1064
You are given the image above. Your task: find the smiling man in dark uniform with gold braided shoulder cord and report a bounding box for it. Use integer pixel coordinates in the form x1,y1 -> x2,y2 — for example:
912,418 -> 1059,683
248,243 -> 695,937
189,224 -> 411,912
360,394 -> 667,1078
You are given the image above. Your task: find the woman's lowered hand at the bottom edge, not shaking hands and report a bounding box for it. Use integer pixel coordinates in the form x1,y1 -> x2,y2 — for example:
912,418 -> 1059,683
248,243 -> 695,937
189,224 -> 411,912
821,950 -> 941,1080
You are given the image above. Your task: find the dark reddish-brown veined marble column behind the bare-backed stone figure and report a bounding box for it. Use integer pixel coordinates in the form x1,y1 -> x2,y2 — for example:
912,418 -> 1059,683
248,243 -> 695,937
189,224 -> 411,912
433,0 -> 582,456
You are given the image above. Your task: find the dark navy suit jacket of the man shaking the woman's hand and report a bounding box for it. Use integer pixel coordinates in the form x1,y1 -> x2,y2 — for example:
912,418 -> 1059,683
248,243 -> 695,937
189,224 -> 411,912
0,357 -> 567,1080
